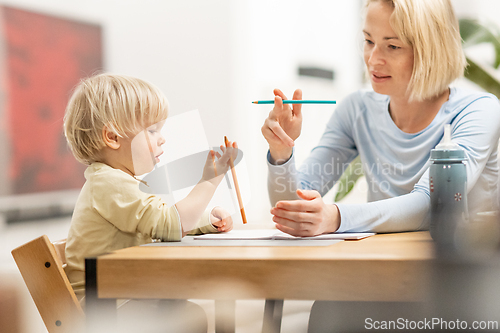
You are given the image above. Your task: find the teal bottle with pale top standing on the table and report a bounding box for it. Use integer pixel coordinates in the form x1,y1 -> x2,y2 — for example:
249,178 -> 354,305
429,124 -> 468,251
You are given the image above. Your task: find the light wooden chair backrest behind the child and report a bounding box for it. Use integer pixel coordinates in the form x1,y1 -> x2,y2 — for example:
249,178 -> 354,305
12,235 -> 85,333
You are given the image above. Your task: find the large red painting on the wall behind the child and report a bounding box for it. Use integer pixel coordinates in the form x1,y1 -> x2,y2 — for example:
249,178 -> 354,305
0,7 -> 102,194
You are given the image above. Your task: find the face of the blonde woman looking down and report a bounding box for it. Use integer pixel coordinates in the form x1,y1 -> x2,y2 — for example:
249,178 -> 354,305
363,1 -> 413,97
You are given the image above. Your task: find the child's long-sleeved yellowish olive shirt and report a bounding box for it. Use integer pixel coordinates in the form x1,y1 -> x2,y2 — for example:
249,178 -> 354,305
65,163 -> 217,300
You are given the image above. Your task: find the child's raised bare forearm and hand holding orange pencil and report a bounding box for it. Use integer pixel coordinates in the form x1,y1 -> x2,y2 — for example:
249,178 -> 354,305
175,142 -> 238,237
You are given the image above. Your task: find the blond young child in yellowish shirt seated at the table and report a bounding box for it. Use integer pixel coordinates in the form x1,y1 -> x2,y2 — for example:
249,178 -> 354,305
64,74 -> 237,332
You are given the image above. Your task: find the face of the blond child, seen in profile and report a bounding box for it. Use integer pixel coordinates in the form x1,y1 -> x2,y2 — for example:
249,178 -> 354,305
130,121 -> 165,176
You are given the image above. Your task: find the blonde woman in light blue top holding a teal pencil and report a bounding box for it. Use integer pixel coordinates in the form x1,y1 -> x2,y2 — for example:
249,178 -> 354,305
262,0 -> 500,236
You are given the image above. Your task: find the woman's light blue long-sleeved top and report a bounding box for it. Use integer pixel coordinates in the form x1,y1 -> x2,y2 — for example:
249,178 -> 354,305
268,88 -> 500,233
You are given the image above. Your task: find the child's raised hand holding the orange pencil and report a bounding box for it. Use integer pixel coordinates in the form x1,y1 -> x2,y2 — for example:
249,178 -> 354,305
202,142 -> 238,186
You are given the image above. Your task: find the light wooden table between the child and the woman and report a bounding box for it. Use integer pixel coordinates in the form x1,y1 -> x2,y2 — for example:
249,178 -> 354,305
86,232 -> 434,330
